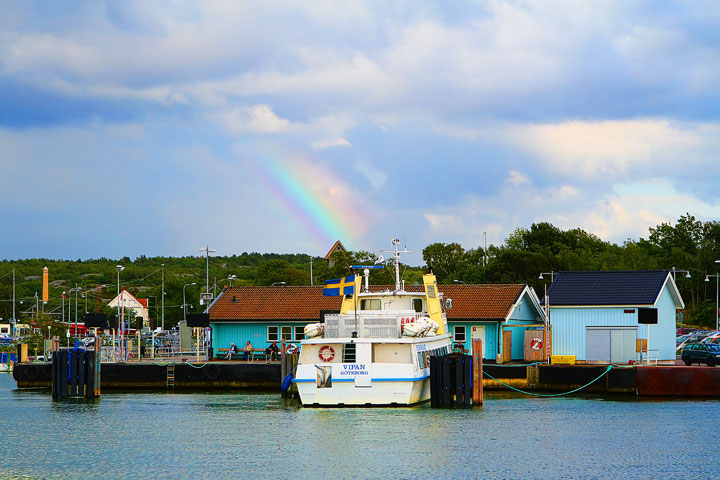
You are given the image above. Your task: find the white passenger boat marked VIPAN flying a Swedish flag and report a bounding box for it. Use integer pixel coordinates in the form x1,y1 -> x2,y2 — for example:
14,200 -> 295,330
293,239 -> 452,407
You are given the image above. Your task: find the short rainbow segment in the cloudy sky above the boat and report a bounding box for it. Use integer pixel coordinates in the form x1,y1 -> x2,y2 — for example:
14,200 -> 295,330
256,152 -> 365,249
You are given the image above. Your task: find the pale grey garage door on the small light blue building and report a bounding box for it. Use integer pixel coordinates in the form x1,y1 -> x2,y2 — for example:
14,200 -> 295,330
585,327 -> 637,363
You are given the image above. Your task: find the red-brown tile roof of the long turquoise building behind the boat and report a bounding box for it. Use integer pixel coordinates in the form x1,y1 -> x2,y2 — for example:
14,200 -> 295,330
210,284 -> 525,321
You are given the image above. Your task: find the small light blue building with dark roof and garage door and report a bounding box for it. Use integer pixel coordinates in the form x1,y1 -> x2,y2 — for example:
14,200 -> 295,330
543,270 -> 685,364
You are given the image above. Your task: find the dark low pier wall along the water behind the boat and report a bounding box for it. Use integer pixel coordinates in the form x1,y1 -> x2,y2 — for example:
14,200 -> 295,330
13,359 -> 720,397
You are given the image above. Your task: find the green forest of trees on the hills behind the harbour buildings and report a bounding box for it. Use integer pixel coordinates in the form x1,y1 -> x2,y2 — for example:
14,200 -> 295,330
0,213 -> 720,328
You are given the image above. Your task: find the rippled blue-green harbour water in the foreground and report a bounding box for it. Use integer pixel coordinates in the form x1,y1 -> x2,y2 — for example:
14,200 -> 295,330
0,374 -> 720,479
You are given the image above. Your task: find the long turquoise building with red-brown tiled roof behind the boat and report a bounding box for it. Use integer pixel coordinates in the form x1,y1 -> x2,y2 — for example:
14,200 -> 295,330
208,284 -> 545,361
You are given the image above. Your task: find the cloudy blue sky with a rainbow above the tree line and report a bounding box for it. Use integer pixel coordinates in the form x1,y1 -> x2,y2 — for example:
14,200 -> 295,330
0,0 -> 720,265
